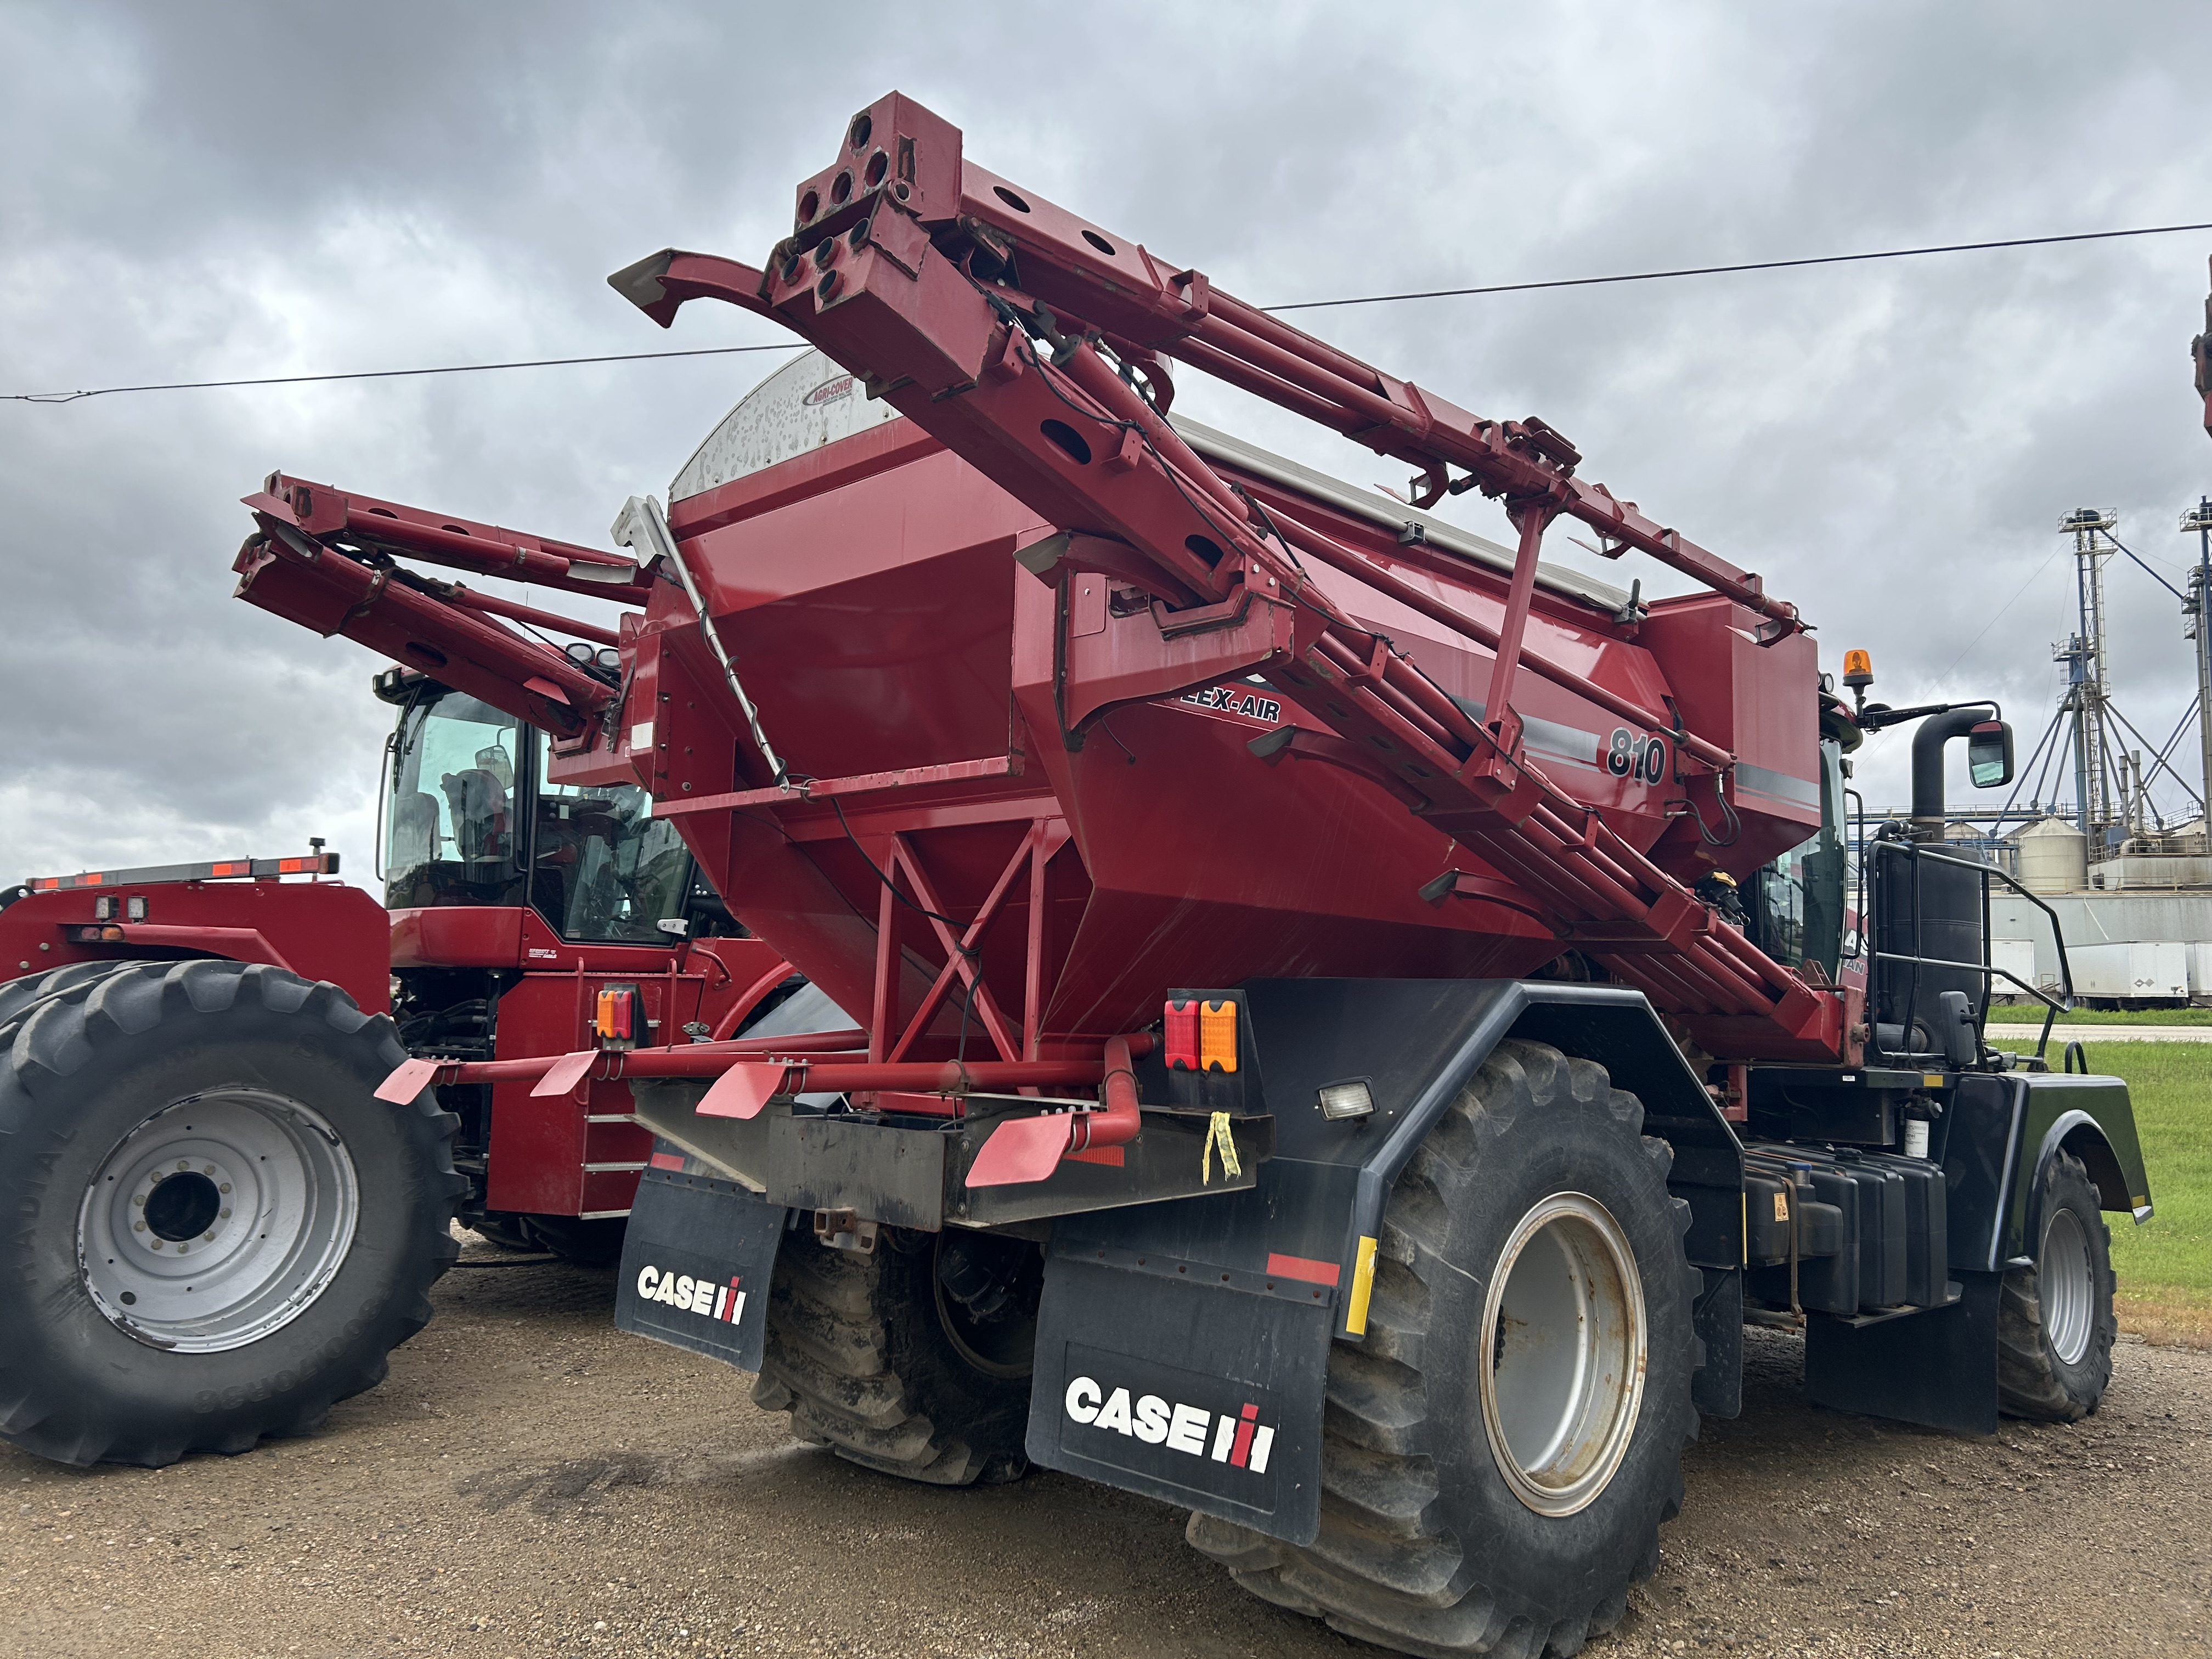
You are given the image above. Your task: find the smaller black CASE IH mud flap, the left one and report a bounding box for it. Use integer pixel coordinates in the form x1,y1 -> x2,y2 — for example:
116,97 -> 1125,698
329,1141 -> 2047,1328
615,1142 -> 789,1372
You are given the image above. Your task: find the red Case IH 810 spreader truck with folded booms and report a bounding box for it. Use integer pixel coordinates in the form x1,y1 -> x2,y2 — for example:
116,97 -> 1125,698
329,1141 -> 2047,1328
0,95 -> 2150,1655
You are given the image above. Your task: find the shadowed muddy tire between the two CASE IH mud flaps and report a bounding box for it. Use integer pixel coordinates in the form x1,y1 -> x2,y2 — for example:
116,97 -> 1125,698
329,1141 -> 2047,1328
752,1228 -> 1042,1487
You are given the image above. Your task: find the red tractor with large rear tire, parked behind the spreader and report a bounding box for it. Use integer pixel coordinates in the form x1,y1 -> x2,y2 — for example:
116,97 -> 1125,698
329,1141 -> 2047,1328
0,663 -> 792,1464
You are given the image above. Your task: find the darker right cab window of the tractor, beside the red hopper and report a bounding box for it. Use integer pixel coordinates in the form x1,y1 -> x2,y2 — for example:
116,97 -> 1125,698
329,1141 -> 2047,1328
531,732 -> 692,945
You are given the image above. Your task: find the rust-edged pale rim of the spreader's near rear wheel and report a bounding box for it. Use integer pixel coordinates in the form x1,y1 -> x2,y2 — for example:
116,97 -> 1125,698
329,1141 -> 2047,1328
1475,1192 -> 1650,1515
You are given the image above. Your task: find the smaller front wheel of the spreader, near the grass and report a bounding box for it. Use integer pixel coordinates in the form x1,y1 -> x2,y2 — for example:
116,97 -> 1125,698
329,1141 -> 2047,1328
1997,1153 -> 2119,1423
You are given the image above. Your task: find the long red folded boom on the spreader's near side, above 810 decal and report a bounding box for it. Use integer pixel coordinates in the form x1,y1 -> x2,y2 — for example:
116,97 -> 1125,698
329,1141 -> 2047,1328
611,95 -> 1849,1057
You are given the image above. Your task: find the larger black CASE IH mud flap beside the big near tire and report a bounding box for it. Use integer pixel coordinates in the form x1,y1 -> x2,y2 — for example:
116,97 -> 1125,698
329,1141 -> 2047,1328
1029,1212 -> 1338,1544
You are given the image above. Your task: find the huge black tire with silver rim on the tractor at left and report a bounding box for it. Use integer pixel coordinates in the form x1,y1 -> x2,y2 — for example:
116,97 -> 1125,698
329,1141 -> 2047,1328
0,960 -> 465,1466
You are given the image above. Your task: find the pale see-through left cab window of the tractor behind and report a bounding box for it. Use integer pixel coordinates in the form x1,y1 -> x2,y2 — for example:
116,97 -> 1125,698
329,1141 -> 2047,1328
385,686 -> 522,909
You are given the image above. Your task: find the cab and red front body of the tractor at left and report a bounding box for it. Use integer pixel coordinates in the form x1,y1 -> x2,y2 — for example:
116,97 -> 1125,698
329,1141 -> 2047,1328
374,659 -> 792,1261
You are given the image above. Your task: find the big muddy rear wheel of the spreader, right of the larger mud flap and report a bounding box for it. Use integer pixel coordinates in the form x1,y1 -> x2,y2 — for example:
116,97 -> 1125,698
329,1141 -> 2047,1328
1188,1042 -> 1701,1659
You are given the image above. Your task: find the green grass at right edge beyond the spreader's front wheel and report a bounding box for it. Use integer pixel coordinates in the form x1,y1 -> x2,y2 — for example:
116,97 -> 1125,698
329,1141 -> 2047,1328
2088,1042 -> 2212,1340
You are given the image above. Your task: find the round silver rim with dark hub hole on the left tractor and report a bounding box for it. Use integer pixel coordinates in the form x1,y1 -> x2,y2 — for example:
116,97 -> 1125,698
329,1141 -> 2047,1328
77,1088 -> 360,1354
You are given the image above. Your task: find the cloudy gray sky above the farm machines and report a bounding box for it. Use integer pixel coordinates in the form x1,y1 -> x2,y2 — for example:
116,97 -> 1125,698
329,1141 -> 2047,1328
0,0 -> 2212,881
